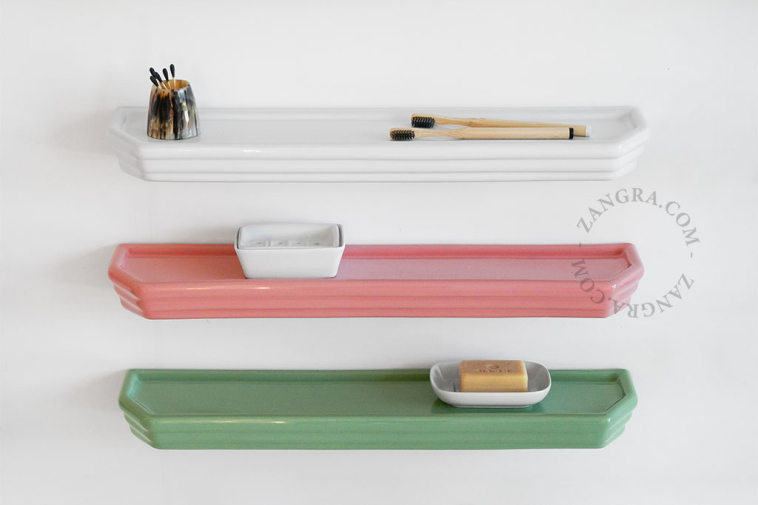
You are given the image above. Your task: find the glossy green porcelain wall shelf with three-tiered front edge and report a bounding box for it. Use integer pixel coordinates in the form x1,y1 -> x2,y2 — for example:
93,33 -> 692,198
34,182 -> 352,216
119,370 -> 637,449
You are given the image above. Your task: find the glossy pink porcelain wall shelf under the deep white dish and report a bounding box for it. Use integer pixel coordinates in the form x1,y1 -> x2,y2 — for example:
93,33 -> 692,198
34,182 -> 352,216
108,244 -> 643,319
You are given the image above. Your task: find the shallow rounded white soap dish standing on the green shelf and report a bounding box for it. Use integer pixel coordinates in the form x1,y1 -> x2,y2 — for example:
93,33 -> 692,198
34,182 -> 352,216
429,361 -> 551,409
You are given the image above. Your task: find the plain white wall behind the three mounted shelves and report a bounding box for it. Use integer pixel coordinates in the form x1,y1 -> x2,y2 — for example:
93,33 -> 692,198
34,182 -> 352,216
0,0 -> 758,505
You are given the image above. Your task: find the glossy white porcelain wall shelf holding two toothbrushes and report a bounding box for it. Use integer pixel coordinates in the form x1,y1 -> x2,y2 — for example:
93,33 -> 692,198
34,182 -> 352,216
109,107 -> 649,182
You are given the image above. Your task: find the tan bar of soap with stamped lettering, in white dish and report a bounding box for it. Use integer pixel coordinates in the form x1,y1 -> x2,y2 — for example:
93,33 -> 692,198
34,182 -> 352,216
460,360 -> 529,393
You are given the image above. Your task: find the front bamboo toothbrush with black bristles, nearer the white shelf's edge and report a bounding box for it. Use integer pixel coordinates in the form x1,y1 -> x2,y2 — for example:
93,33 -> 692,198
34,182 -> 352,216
390,126 -> 574,140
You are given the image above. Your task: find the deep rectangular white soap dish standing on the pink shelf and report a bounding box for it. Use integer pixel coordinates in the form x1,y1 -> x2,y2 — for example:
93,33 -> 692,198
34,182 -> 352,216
234,223 -> 345,279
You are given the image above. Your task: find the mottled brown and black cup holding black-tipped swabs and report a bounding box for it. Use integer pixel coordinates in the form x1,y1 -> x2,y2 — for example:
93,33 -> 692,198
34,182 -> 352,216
147,79 -> 200,140
